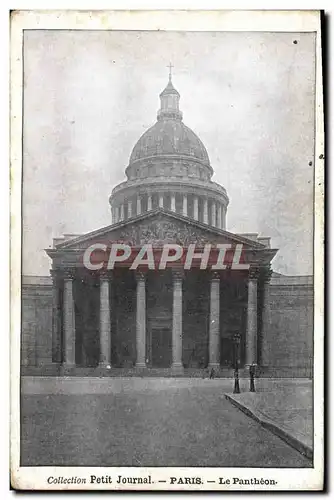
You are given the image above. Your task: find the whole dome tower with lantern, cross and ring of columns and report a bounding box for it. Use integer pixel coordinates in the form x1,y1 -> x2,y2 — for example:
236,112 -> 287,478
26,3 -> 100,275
109,70 -> 229,228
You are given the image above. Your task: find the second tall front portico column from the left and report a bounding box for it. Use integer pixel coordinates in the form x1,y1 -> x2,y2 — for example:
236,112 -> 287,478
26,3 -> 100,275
99,274 -> 111,367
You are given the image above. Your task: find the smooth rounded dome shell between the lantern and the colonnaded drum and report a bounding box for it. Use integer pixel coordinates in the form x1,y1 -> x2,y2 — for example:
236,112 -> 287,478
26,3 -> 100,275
130,118 -> 210,165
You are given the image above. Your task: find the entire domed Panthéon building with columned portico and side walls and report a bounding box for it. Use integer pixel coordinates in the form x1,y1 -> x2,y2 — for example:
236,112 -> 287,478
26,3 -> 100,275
22,71 -> 313,376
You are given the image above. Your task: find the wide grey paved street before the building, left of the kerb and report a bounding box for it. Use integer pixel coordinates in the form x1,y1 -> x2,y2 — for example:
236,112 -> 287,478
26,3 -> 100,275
21,377 -> 312,467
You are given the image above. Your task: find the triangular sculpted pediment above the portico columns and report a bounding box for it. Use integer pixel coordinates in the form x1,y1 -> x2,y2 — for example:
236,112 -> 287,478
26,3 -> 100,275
52,208 -> 265,250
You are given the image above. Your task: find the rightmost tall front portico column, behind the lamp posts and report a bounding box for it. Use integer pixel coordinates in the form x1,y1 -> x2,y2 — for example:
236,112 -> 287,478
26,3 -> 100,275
246,268 -> 258,365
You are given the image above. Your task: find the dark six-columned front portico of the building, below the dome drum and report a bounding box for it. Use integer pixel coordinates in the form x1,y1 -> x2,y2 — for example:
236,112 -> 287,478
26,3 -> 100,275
48,209 -> 275,374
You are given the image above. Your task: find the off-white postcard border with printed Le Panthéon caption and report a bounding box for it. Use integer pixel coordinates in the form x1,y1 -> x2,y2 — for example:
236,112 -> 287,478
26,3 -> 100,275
10,10 -> 324,491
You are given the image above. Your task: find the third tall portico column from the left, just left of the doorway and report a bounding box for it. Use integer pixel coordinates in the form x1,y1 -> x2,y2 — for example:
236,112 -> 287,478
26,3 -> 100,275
136,273 -> 146,368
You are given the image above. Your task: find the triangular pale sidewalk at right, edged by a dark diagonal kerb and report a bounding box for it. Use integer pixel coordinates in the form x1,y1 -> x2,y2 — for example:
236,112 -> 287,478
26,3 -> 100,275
225,379 -> 313,458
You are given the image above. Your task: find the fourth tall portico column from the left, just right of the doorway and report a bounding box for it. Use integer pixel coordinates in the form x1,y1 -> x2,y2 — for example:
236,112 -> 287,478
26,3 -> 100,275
172,272 -> 183,373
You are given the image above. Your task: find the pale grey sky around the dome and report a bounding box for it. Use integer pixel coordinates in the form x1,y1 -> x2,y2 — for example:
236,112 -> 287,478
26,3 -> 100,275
22,30 -> 315,276
